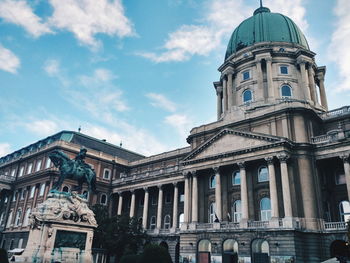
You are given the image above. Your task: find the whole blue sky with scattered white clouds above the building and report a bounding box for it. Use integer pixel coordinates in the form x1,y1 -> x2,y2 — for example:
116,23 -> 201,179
0,0 -> 350,156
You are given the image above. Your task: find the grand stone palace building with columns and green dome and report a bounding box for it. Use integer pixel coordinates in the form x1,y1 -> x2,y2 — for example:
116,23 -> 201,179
0,4 -> 350,263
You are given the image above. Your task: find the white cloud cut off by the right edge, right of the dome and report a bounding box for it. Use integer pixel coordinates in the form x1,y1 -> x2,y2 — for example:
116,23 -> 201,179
328,0 -> 350,91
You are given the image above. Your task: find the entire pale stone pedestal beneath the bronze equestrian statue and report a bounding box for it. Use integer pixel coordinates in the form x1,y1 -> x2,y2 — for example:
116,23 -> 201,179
16,191 -> 97,263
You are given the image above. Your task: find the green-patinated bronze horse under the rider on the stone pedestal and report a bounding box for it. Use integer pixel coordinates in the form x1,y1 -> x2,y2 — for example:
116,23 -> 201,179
49,150 -> 96,192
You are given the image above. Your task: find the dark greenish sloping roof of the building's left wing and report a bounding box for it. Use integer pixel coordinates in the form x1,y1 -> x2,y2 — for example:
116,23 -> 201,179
0,131 -> 145,164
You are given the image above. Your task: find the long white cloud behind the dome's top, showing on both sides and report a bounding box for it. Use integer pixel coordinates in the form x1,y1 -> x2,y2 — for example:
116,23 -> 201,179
136,0 -> 308,63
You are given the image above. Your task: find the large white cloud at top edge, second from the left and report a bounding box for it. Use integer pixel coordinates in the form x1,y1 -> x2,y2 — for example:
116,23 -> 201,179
49,0 -> 135,48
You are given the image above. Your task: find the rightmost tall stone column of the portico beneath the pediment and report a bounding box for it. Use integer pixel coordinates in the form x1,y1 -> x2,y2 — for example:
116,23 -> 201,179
278,154 -> 293,217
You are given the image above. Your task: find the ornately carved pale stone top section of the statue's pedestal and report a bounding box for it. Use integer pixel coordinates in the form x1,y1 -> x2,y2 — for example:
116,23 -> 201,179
30,191 -> 97,229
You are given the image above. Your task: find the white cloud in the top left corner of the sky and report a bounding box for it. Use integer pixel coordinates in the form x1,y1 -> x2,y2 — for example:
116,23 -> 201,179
0,0 -> 52,37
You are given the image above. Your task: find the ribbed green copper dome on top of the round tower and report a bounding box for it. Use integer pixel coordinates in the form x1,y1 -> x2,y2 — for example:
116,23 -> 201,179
225,7 -> 309,60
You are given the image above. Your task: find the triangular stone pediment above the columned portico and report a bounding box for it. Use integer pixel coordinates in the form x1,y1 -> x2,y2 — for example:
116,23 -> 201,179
183,129 -> 284,162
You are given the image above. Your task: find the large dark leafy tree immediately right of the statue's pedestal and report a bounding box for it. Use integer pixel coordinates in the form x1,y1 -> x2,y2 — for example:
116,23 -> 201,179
93,205 -> 149,262
